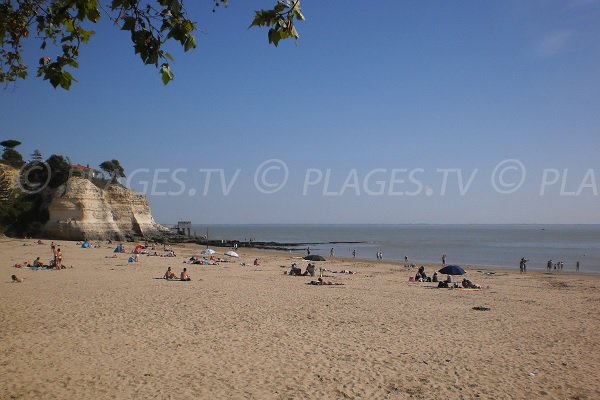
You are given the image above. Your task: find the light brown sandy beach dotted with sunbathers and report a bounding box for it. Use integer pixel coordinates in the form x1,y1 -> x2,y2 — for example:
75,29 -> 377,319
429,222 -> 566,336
0,238 -> 600,400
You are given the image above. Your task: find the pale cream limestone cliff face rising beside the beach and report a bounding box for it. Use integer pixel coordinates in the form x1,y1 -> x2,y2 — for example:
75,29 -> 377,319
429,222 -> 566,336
43,177 -> 170,240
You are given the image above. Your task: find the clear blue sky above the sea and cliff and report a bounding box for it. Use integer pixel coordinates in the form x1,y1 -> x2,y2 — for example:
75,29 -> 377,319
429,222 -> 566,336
0,0 -> 600,224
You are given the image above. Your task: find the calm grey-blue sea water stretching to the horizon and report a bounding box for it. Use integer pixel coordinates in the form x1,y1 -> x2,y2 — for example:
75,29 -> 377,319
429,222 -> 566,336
193,225 -> 600,273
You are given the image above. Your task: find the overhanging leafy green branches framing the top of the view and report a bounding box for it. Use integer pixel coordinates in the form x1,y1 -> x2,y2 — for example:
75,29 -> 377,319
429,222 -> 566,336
0,0 -> 304,90
